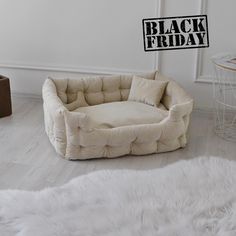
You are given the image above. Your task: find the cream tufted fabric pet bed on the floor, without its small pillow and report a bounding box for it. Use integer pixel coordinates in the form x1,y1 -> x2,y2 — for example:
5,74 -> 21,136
43,72 -> 193,160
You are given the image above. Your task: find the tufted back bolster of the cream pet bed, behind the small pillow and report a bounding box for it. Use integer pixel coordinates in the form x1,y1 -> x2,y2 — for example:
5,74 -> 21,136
51,72 -> 156,108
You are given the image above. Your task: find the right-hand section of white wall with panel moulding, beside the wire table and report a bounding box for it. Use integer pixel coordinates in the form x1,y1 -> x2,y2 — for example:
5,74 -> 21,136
161,0 -> 236,109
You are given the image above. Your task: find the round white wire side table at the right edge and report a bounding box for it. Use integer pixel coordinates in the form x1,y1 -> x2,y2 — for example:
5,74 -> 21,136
212,54 -> 236,142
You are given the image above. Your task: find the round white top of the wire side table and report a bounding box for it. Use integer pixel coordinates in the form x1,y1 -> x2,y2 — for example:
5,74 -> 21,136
211,53 -> 236,72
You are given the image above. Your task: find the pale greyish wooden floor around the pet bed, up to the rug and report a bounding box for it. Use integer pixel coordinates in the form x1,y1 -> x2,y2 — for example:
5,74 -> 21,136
0,98 -> 236,190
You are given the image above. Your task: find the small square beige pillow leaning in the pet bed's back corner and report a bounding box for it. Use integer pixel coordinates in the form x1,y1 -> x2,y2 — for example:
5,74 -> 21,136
128,75 -> 167,107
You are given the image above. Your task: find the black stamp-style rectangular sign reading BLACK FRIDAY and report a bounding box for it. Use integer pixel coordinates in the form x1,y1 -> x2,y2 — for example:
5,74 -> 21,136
143,15 -> 209,52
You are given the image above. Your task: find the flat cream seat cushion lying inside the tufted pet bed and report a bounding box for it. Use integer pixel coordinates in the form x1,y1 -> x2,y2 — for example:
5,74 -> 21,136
74,101 -> 168,128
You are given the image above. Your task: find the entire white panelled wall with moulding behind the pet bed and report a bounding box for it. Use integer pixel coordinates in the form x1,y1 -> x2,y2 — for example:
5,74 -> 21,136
0,0 -> 236,108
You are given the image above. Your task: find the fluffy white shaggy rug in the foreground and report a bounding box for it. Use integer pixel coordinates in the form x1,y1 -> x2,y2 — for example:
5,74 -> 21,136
0,158 -> 236,236
